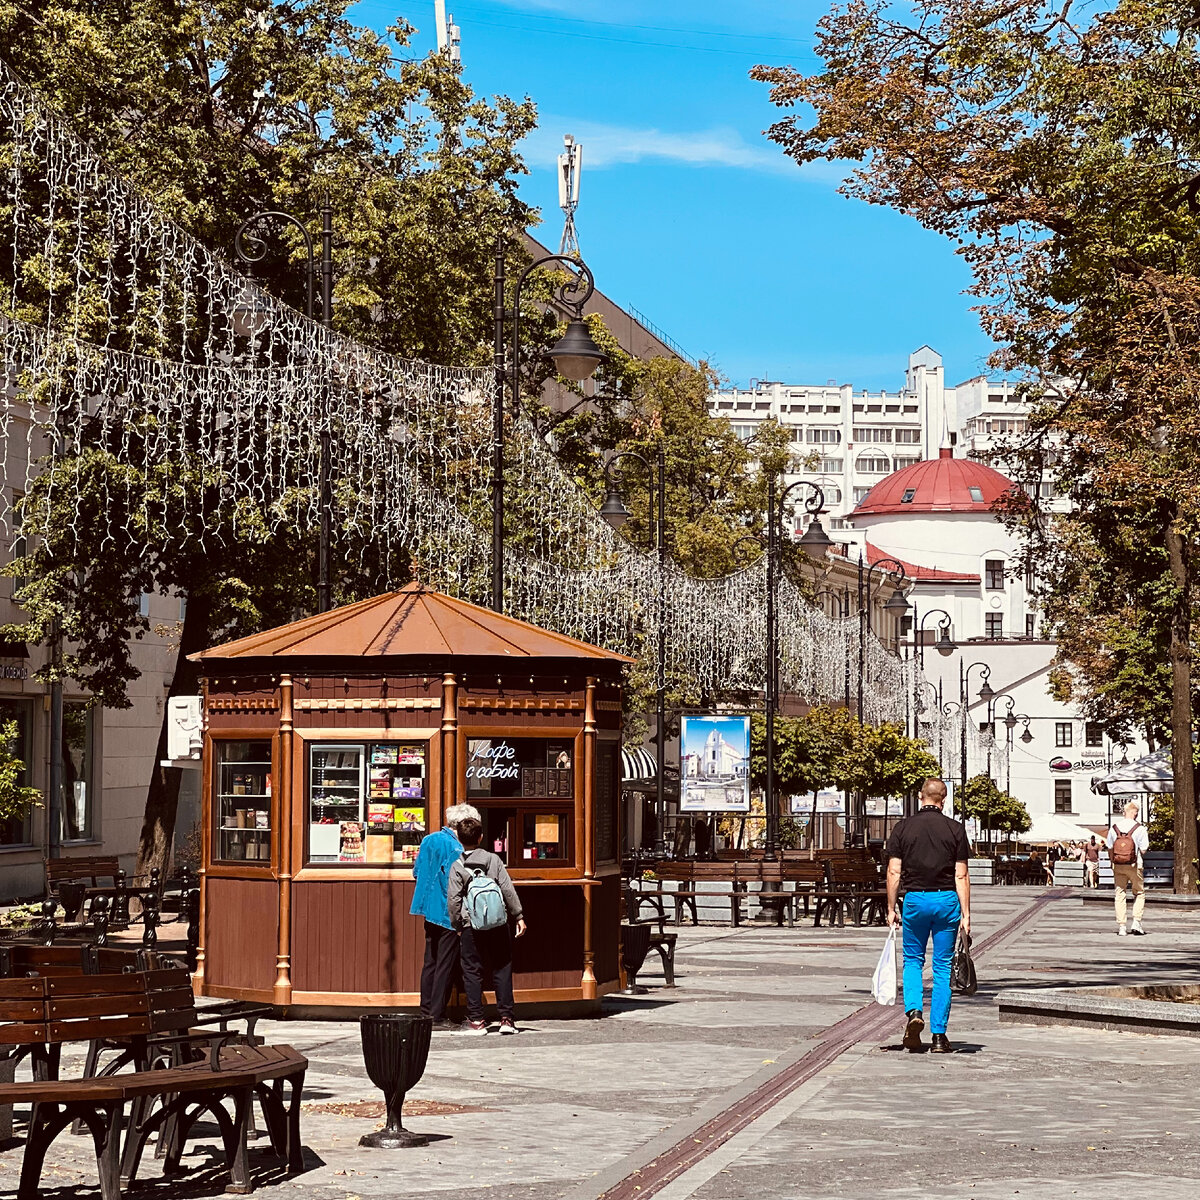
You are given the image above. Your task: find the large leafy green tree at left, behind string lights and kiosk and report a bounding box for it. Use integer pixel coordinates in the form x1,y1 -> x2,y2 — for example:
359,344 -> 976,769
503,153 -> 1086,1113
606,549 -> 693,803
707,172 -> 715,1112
0,0 -> 534,874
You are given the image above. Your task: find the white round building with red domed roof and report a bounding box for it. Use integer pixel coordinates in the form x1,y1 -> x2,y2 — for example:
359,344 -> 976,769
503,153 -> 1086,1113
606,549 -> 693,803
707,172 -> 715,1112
850,448 -> 1145,830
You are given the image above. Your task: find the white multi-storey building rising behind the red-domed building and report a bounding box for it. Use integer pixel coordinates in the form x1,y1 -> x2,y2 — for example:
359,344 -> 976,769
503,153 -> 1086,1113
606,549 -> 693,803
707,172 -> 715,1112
709,346 -> 1054,530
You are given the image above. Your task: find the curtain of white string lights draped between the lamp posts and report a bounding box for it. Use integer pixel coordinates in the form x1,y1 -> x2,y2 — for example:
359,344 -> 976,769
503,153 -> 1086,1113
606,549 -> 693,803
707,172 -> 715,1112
0,60 -> 908,721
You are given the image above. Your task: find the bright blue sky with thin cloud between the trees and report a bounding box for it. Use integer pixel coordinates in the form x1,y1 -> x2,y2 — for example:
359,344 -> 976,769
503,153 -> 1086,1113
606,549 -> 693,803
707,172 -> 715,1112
353,0 -> 990,389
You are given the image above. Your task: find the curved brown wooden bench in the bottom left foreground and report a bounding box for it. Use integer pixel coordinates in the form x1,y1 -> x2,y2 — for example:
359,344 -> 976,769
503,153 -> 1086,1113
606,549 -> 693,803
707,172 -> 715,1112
0,970 -> 300,1200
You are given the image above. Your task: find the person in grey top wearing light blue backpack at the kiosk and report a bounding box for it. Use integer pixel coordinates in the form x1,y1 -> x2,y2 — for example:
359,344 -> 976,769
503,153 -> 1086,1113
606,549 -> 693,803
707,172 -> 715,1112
449,814 -> 526,1037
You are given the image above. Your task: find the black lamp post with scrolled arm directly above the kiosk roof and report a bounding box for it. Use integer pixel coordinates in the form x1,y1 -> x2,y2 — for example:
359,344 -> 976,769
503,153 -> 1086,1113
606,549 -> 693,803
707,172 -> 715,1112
492,235 -> 605,612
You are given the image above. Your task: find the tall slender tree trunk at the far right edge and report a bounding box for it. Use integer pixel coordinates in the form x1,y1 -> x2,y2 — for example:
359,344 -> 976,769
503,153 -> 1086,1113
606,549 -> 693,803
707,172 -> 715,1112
1165,510 -> 1200,893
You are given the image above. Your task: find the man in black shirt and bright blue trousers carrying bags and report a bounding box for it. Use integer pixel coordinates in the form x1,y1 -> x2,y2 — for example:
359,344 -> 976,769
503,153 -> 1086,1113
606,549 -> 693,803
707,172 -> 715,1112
887,779 -> 971,1054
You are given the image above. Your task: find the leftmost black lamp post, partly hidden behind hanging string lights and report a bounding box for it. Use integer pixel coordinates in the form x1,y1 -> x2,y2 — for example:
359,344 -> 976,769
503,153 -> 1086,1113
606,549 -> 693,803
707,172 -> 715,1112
230,204 -> 334,612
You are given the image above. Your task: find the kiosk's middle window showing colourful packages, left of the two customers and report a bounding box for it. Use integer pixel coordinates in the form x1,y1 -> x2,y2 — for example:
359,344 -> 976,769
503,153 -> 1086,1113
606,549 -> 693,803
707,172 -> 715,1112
308,742 -> 428,866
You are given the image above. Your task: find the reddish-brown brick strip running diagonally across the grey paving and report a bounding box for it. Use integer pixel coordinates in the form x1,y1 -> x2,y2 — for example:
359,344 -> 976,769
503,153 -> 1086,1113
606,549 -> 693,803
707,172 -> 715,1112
576,888 -> 1070,1200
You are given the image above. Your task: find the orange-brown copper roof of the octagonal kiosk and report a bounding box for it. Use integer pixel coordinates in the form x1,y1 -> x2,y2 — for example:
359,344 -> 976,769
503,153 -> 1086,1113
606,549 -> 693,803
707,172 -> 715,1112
191,583 -> 634,662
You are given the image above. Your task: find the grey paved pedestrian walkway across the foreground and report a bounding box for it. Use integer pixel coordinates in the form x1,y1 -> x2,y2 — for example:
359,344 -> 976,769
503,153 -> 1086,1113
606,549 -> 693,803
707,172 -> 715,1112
0,888 -> 1200,1200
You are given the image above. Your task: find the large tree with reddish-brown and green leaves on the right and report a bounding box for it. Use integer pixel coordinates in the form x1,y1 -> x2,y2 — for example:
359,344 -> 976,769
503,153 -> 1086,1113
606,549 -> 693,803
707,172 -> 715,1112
754,0 -> 1200,892
